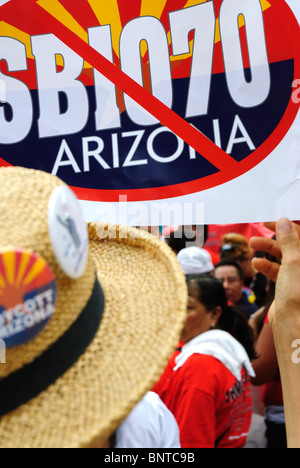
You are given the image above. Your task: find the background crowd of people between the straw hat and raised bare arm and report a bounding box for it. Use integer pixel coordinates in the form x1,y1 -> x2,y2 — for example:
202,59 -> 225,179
115,224 -> 300,448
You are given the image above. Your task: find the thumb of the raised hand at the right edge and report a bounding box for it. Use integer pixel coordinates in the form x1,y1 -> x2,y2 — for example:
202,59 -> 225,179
276,218 -> 300,261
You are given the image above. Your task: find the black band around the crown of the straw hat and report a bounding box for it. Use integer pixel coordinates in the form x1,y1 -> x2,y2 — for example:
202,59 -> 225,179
0,279 -> 104,416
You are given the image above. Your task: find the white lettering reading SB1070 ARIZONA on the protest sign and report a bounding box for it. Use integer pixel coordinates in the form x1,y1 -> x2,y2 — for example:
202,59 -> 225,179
0,0 -> 272,145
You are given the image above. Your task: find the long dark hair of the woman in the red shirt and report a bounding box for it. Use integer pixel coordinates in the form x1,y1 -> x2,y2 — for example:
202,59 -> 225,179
186,275 -> 257,360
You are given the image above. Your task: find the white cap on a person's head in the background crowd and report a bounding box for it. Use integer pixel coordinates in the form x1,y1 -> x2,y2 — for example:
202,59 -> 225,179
177,247 -> 214,275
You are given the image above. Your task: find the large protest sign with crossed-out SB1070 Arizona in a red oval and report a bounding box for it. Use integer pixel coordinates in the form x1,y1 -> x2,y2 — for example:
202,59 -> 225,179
0,0 -> 300,225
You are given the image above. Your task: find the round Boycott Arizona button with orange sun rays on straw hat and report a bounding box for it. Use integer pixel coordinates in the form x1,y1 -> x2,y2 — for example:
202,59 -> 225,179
0,247 -> 56,349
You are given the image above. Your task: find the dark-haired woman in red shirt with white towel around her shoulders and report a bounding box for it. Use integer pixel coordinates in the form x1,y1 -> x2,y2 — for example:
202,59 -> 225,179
153,276 -> 256,448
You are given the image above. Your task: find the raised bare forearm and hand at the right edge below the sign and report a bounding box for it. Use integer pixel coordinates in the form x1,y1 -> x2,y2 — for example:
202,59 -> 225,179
251,218 -> 300,448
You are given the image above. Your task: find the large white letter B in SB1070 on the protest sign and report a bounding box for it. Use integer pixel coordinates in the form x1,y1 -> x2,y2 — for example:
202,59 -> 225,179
31,34 -> 89,138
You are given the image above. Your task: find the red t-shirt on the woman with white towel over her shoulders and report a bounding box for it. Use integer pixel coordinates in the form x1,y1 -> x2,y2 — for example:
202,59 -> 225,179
154,352 -> 252,448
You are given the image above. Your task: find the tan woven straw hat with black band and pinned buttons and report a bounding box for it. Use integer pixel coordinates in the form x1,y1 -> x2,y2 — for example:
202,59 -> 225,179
0,168 -> 187,448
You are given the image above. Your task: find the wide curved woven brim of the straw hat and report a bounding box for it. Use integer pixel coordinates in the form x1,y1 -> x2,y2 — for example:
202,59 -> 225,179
0,224 -> 187,448
